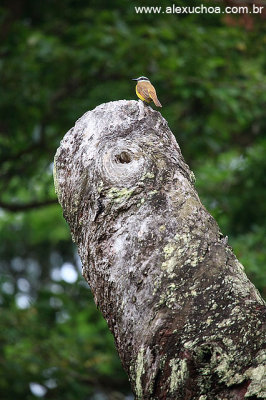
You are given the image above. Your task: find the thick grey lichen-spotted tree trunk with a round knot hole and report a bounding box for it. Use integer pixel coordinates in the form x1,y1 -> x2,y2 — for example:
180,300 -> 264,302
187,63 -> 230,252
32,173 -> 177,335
55,100 -> 266,400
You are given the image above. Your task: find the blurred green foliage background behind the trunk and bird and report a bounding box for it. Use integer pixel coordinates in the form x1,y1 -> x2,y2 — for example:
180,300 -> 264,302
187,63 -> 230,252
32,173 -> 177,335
0,0 -> 266,400
